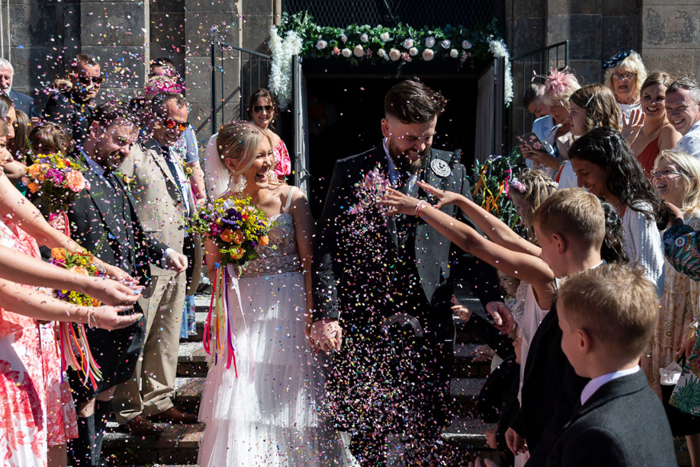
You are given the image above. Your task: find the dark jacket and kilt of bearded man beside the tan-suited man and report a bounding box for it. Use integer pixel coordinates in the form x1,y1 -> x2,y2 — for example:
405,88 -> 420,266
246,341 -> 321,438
42,153 -> 168,402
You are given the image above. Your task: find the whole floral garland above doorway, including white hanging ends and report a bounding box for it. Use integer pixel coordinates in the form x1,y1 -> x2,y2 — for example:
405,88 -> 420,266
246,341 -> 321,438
270,12 -> 513,110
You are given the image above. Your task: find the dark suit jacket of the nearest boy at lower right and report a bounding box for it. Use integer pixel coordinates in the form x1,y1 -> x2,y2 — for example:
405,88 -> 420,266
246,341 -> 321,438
538,371 -> 677,467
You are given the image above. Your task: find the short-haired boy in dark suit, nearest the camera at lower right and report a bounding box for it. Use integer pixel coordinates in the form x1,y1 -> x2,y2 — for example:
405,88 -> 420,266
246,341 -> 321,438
546,264 -> 676,467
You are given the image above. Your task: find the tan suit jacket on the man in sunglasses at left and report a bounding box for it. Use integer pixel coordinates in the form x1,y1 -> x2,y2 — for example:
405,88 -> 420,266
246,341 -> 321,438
121,139 -> 195,275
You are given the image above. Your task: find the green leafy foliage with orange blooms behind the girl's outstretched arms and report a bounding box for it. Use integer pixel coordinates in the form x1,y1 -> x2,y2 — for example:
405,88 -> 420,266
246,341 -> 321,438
470,150 -> 527,238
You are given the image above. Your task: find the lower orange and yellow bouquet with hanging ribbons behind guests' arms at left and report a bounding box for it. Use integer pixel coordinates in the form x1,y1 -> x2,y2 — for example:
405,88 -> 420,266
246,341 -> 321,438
49,248 -> 106,387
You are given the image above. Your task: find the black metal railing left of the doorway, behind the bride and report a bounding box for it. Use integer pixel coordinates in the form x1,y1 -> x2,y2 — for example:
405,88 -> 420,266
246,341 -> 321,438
211,41 -> 272,134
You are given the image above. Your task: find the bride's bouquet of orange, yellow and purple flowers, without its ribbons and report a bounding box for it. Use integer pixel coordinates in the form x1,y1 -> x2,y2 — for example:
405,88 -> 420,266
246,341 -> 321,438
190,198 -> 271,274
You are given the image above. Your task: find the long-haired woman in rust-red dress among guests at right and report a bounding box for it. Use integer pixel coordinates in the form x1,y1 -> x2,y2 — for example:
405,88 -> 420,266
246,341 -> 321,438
621,71 -> 681,176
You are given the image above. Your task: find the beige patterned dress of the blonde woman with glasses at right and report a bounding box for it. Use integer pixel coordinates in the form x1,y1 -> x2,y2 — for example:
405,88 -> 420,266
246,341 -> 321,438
642,212 -> 700,397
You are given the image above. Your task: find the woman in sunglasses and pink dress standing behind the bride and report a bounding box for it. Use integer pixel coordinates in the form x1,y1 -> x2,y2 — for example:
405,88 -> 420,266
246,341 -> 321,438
246,88 -> 292,183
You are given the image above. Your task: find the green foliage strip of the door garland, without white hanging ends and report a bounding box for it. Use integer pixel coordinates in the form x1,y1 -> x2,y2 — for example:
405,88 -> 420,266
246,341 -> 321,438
278,11 -> 503,66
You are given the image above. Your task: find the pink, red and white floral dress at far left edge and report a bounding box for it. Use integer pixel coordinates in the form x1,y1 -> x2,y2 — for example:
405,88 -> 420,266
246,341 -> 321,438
0,219 -> 78,466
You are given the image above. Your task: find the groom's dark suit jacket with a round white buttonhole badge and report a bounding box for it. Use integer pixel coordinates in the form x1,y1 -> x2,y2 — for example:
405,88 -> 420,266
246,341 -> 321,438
312,145 -> 501,328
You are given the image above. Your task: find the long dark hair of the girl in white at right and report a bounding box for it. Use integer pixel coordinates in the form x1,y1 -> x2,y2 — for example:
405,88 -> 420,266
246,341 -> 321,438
569,127 -> 667,222
